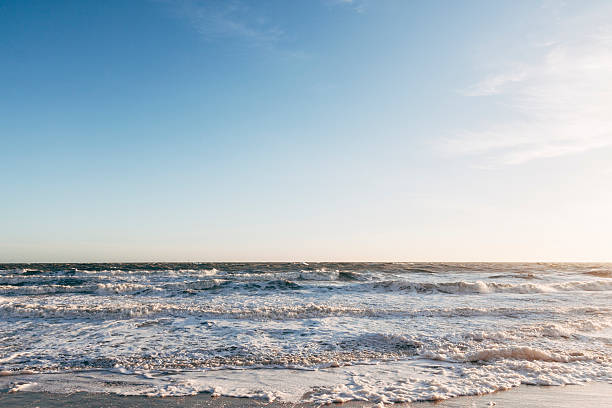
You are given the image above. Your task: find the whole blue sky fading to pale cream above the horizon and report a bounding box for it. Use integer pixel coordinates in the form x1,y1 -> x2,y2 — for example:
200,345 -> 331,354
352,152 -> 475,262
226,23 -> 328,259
0,0 -> 612,262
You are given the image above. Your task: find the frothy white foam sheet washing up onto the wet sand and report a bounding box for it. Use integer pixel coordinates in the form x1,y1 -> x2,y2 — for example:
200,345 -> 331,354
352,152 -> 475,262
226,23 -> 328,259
0,360 -> 611,404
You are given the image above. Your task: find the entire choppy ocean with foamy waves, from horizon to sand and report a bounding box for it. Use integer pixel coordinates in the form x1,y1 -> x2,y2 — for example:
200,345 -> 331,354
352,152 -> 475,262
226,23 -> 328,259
0,263 -> 612,404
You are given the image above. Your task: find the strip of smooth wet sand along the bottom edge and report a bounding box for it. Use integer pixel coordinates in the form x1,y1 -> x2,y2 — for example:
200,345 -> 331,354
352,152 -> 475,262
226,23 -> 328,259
0,383 -> 612,408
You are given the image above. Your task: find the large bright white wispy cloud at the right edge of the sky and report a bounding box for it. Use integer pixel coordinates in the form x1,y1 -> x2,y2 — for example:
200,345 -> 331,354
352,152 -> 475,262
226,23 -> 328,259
442,30 -> 612,165
